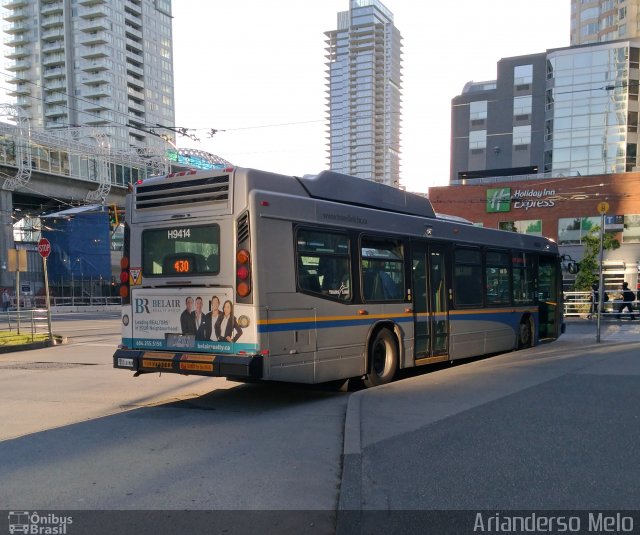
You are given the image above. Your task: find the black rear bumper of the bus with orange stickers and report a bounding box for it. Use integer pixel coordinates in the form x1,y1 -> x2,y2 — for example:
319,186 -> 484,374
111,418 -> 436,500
113,349 -> 262,379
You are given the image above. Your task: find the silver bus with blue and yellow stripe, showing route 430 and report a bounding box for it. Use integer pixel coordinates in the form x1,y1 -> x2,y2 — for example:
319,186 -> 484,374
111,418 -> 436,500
113,168 -> 563,386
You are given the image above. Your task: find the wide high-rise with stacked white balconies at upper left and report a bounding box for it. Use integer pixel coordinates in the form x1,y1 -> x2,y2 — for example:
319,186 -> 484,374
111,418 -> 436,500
2,0 -> 175,149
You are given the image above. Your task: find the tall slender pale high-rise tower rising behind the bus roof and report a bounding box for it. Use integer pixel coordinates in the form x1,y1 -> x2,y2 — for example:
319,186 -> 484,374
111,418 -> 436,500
325,0 -> 402,187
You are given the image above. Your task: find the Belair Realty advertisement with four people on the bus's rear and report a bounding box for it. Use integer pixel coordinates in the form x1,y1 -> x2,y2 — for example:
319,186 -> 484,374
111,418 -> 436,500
132,288 -> 257,353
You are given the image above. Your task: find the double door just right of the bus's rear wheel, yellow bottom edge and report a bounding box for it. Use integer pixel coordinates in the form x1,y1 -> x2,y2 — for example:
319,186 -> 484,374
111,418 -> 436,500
412,242 -> 449,364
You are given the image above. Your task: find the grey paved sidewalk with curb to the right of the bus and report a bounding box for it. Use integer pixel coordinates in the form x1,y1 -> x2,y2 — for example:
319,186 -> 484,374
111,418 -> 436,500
338,319 -> 640,533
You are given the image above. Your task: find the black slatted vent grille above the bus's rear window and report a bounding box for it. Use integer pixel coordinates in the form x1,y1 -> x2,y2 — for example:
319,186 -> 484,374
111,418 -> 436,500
136,175 -> 229,210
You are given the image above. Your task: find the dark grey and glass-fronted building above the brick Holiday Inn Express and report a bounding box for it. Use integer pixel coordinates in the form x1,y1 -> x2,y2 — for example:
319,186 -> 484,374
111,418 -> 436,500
450,40 -> 640,181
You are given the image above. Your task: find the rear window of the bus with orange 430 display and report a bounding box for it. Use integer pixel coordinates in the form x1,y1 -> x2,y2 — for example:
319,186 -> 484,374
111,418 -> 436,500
142,225 -> 220,277
